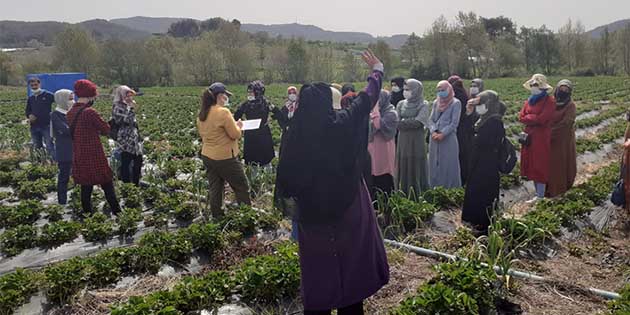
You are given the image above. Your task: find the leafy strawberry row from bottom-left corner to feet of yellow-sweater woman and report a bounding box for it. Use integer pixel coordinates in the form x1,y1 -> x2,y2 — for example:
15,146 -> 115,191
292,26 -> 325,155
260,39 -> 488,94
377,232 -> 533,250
0,207 -> 279,314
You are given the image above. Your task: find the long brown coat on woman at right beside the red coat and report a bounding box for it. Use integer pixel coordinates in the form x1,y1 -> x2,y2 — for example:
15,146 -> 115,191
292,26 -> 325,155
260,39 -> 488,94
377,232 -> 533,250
545,102 -> 577,198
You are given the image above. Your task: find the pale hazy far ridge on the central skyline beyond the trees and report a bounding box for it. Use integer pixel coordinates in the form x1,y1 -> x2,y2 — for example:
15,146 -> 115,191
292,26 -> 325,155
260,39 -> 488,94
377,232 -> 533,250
109,16 -> 408,48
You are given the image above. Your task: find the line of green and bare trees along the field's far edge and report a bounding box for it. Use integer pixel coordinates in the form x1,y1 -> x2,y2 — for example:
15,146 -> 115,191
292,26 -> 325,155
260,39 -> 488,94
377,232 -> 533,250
0,12 -> 630,86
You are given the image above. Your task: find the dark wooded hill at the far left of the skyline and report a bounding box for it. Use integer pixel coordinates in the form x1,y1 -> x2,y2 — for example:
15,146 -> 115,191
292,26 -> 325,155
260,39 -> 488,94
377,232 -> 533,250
0,20 -> 151,47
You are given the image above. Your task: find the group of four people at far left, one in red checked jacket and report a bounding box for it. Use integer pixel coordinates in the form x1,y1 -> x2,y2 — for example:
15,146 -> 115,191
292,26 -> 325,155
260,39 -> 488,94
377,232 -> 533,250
26,78 -> 142,214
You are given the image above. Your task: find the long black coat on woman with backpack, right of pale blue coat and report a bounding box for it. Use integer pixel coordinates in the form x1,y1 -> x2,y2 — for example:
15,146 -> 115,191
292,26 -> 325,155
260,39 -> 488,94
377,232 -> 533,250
462,117 -> 505,229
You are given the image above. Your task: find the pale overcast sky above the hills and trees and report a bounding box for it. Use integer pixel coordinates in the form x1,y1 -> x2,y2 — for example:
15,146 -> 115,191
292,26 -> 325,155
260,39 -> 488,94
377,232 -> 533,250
0,0 -> 630,35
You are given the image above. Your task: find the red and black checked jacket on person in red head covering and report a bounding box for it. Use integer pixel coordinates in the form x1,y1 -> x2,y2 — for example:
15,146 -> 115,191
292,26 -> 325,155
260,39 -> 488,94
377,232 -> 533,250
68,103 -> 113,185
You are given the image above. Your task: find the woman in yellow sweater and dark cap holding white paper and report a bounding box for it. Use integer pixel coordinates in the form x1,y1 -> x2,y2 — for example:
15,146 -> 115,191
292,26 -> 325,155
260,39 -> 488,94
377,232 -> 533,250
197,82 -> 251,219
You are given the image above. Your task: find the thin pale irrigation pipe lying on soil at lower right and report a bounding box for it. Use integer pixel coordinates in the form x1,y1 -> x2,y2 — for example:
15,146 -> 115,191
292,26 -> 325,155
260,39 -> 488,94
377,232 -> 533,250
384,240 -> 621,300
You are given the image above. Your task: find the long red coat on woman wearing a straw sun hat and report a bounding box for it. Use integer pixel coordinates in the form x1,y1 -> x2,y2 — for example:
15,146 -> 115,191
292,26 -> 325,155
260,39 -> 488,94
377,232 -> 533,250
520,96 -> 556,184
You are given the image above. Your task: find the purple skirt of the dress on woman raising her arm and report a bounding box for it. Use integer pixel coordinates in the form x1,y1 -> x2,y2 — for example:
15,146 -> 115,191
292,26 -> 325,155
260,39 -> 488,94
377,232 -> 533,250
298,183 -> 389,310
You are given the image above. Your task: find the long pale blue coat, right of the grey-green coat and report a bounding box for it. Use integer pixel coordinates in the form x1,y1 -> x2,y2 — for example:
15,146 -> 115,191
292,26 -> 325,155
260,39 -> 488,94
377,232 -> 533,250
429,98 -> 462,188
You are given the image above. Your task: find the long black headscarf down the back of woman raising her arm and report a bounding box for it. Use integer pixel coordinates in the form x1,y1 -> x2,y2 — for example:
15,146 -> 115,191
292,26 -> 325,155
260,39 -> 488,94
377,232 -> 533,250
278,83 -> 369,223
